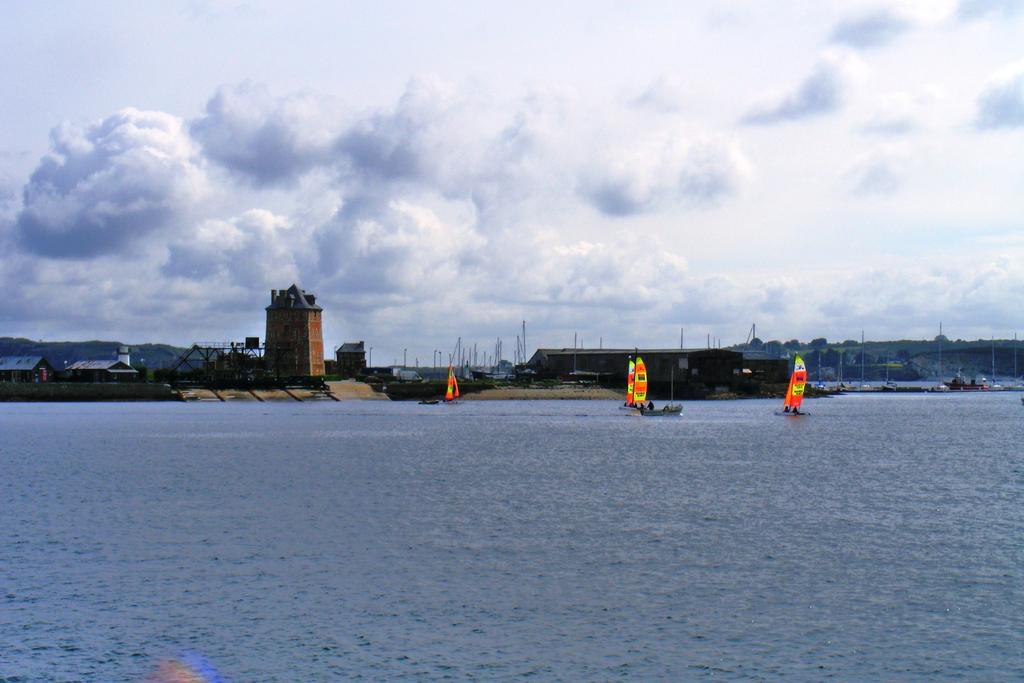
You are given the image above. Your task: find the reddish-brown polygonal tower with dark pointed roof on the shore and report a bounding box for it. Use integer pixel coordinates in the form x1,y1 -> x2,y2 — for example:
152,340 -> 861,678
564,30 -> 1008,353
266,285 -> 324,377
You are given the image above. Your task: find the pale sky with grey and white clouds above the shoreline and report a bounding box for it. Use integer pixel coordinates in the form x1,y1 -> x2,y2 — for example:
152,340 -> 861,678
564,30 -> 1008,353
0,0 -> 1024,364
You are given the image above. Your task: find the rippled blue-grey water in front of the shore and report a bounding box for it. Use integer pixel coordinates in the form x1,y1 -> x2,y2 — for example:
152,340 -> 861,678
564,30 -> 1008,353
0,393 -> 1024,681
